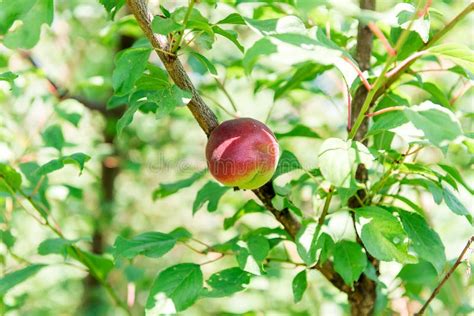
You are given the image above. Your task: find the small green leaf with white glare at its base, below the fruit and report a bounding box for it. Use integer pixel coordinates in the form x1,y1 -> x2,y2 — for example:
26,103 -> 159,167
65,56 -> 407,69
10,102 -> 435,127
236,235 -> 270,275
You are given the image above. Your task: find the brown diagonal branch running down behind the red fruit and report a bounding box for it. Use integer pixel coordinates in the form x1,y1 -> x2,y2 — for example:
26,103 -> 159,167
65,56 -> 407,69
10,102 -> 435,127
127,0 -> 349,292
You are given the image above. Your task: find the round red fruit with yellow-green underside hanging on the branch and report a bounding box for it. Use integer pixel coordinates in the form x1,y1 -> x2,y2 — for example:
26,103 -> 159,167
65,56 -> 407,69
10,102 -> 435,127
206,118 -> 279,189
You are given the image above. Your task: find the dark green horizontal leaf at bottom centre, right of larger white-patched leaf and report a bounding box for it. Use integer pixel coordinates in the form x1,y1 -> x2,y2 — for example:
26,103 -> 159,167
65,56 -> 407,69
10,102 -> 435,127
202,267 -> 251,297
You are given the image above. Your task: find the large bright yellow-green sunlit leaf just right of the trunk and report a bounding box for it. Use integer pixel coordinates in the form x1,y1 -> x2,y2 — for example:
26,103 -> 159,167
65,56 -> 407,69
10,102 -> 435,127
356,206 -> 417,263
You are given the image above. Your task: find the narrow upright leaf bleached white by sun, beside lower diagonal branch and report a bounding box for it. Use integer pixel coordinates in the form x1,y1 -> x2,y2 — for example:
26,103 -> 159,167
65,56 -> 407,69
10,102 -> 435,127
295,221 -> 318,266
